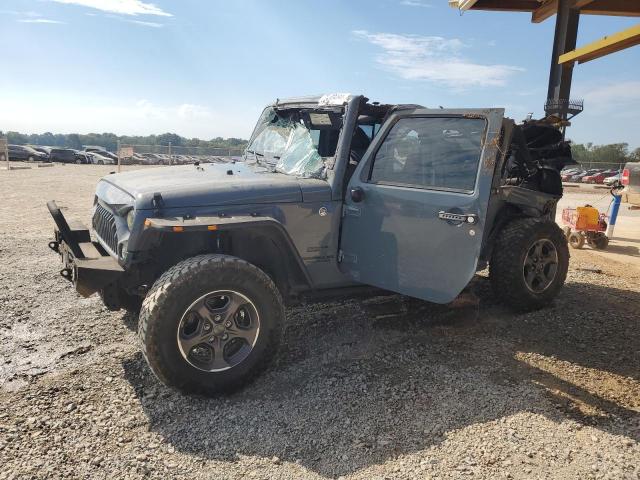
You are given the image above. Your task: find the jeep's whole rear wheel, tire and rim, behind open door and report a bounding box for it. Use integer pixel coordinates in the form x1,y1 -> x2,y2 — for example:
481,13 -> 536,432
489,218 -> 569,311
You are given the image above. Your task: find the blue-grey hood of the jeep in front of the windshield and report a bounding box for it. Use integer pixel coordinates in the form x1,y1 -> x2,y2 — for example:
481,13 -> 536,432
98,162 -> 310,209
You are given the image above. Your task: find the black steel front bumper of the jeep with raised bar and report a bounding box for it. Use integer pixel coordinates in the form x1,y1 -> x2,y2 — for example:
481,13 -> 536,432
47,200 -> 124,297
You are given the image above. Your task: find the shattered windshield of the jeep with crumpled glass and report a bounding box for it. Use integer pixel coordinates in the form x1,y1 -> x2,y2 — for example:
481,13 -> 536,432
245,107 -> 339,178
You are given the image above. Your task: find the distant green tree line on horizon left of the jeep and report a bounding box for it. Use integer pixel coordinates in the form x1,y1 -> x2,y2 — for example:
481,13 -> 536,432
0,131 -> 247,152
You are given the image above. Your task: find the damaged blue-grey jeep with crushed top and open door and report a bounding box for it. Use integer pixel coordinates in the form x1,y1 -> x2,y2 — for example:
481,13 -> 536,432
48,94 -> 573,395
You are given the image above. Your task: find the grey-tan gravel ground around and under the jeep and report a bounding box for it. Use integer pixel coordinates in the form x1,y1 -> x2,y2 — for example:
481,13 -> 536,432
0,165 -> 640,479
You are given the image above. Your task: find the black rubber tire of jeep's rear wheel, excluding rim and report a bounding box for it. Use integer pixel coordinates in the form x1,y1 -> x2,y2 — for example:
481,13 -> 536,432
489,218 -> 569,312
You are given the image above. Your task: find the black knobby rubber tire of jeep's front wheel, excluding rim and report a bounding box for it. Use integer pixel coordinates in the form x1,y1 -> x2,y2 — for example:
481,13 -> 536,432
138,255 -> 285,396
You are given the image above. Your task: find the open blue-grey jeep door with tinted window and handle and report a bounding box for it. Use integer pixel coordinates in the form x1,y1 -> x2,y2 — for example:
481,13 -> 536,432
338,109 -> 504,303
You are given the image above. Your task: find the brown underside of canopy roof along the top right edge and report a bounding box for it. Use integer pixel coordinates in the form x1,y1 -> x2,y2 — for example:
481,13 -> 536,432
449,0 -> 640,23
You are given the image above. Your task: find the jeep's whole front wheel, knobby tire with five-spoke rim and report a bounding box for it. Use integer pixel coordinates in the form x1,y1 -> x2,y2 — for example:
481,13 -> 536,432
138,255 -> 284,395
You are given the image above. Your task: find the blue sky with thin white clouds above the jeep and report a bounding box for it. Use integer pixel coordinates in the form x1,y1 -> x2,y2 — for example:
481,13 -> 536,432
0,0 -> 640,146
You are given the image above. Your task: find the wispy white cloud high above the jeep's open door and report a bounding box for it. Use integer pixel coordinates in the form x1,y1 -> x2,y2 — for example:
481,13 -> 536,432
353,30 -> 524,89
